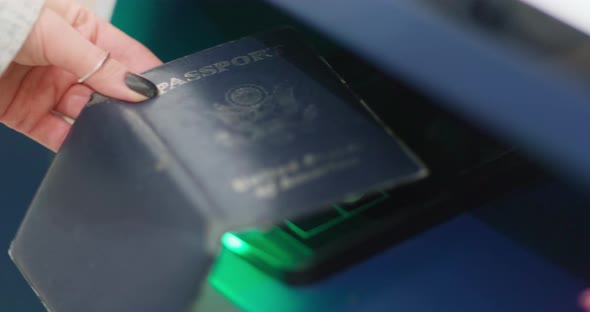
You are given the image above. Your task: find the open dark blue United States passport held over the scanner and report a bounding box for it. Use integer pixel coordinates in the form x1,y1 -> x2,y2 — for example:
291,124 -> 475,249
10,29 -> 427,311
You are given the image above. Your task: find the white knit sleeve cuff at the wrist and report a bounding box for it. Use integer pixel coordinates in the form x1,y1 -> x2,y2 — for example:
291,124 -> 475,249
0,0 -> 45,76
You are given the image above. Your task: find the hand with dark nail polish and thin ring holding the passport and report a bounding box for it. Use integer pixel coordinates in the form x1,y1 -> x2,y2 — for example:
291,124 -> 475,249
0,0 -> 162,151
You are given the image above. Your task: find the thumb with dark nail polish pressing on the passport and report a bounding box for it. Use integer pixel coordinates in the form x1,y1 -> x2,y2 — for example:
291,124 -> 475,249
15,9 -> 158,102
